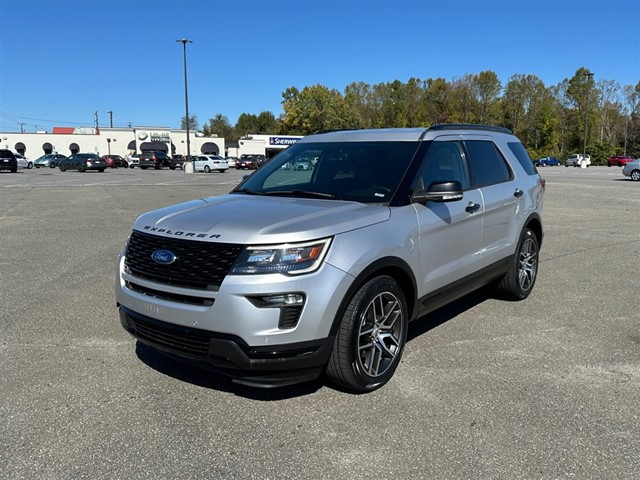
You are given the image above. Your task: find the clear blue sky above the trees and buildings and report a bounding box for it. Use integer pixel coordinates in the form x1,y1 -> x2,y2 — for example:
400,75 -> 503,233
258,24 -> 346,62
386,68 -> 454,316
0,0 -> 640,131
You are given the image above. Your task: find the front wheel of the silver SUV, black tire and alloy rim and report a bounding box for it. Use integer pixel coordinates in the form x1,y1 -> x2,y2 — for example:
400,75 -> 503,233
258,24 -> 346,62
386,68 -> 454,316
326,275 -> 408,392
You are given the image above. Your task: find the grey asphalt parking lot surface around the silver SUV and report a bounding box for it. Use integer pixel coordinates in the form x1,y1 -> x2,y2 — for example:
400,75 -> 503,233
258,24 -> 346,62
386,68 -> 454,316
0,167 -> 640,480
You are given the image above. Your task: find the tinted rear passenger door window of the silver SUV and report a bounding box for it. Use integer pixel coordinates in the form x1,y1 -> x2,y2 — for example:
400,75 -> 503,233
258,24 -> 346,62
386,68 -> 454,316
464,140 -> 511,187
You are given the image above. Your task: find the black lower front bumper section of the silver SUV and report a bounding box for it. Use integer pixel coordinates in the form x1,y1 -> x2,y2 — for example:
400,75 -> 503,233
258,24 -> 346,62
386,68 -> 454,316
119,305 -> 334,387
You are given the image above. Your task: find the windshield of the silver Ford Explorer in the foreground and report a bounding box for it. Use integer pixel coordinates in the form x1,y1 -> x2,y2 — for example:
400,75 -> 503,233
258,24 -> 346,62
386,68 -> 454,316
233,142 -> 419,203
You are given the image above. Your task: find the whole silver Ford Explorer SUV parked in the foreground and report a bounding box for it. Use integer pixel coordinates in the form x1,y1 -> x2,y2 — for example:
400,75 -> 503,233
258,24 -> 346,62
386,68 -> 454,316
116,125 -> 544,392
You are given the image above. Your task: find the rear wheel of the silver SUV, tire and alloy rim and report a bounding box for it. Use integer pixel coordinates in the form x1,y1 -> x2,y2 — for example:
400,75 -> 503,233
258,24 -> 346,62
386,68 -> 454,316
498,228 -> 540,300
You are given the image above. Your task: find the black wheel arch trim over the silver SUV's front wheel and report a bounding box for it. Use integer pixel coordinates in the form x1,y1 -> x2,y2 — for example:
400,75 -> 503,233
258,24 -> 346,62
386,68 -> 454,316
330,257 -> 418,336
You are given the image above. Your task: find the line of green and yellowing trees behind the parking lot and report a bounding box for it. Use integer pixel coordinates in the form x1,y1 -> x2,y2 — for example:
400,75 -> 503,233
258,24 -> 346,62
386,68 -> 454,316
182,67 -> 640,165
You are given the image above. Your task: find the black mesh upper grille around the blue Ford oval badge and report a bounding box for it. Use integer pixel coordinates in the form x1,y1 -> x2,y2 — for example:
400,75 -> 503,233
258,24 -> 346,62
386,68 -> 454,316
125,231 -> 242,291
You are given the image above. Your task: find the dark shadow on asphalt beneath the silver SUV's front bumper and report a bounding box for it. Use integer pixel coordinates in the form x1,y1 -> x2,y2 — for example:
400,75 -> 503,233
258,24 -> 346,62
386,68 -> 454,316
136,341 -> 323,401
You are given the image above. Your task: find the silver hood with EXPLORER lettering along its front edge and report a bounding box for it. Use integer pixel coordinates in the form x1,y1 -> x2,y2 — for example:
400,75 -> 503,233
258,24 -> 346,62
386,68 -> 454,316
133,194 -> 390,245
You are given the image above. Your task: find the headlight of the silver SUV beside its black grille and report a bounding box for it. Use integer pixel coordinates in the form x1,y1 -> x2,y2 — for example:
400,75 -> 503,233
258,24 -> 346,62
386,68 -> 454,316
229,238 -> 331,275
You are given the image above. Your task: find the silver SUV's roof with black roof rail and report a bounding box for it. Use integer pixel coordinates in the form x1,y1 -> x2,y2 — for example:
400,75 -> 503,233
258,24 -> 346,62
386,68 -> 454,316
299,124 -> 513,143
